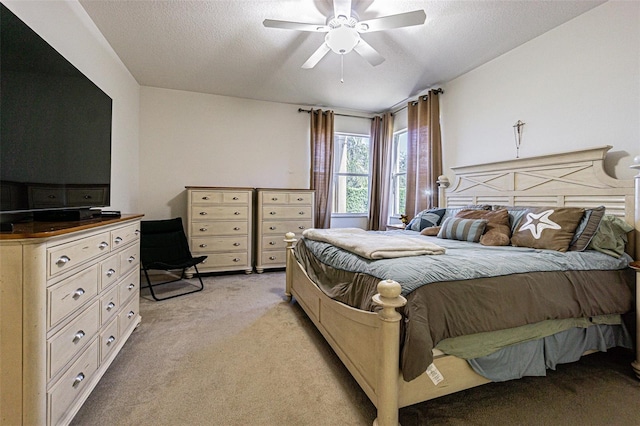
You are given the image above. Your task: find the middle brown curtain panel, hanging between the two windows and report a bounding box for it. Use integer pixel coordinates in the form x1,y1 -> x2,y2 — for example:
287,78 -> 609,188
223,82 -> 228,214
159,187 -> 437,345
367,112 -> 393,231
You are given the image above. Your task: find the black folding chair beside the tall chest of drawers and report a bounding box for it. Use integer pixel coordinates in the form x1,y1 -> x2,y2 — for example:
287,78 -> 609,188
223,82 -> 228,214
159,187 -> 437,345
140,217 -> 207,300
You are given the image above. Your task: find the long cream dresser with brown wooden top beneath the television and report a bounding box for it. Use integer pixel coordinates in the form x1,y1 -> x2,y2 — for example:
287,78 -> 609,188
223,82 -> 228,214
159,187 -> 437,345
0,215 -> 142,425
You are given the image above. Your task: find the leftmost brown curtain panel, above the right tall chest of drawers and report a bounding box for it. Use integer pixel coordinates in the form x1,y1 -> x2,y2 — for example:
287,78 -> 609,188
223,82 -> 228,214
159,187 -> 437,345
309,109 -> 333,229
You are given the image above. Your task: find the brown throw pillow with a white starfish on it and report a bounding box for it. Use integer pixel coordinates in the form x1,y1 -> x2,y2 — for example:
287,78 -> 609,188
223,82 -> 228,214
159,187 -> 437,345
511,207 -> 584,252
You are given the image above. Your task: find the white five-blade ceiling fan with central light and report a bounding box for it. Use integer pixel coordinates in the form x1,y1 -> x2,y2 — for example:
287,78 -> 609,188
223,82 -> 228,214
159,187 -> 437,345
262,0 -> 427,69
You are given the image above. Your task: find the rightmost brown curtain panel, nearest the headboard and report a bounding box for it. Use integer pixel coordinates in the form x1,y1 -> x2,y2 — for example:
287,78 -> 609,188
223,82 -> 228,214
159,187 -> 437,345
406,90 -> 442,218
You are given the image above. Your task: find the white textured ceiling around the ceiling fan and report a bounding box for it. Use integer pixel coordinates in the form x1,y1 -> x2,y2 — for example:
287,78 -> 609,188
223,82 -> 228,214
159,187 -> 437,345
80,0 -> 603,112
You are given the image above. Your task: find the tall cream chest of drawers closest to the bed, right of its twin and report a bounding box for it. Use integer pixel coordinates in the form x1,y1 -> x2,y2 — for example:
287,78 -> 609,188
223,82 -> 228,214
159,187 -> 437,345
256,188 -> 314,273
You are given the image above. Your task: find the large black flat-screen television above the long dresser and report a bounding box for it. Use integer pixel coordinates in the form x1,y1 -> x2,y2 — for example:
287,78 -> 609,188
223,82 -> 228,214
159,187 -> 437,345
0,4 -> 112,213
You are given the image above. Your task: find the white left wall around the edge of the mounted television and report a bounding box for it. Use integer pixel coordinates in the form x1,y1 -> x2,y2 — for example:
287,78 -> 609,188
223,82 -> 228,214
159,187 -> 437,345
2,0 -> 140,213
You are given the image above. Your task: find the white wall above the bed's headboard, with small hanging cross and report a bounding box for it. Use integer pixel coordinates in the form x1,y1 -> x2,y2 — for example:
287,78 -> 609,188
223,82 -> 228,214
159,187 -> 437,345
440,0 -> 640,179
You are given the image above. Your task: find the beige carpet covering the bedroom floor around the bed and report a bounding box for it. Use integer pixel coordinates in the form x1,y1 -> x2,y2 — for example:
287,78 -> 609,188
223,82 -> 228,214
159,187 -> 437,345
73,272 -> 640,426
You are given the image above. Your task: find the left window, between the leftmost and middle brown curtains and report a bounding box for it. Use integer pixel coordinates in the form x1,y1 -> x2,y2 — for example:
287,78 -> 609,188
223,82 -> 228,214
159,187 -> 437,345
332,133 -> 370,215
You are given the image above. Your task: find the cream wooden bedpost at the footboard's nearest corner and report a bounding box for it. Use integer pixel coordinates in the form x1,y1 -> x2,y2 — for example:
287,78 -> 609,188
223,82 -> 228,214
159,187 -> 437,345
373,280 -> 407,426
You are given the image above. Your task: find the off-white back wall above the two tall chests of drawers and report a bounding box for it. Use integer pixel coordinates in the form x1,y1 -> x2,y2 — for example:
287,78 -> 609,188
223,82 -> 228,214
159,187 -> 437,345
140,87 -> 310,219
